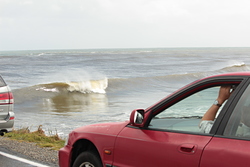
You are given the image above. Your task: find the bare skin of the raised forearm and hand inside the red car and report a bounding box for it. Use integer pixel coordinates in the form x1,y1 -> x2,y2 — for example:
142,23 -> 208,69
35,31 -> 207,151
202,86 -> 231,121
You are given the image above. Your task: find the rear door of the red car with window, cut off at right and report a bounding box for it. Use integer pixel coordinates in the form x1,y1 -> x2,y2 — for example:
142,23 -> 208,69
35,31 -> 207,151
200,80 -> 250,167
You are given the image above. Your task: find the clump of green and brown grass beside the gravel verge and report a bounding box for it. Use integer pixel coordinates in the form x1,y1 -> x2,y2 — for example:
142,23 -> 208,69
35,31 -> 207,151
4,125 -> 65,150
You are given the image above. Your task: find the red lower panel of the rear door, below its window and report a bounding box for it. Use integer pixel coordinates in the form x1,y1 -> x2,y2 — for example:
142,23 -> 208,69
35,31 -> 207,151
200,137 -> 250,167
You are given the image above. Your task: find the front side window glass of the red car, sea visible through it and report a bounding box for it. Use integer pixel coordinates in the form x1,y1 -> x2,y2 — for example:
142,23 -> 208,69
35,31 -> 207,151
149,87 -> 222,133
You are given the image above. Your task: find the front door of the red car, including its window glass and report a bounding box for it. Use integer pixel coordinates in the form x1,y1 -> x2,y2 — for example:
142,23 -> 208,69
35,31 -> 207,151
113,80 -> 244,167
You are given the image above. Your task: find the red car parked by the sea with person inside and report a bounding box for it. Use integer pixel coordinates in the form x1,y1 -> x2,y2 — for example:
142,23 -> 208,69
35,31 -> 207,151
59,72 -> 250,167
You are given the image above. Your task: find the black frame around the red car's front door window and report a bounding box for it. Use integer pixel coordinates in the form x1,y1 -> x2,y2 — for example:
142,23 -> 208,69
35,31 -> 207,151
145,76 -> 246,135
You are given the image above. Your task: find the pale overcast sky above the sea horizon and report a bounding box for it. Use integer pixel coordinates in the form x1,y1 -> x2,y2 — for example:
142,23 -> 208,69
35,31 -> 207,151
0,0 -> 250,50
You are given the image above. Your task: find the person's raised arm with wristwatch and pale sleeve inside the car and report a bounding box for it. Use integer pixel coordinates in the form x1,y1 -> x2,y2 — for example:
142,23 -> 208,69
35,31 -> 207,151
199,86 -> 232,133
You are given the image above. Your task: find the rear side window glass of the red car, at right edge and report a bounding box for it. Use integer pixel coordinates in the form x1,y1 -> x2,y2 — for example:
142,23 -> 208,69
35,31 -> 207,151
224,85 -> 250,139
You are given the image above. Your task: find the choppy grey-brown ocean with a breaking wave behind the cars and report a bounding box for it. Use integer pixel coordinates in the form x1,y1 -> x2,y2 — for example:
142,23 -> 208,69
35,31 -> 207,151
0,48 -> 250,137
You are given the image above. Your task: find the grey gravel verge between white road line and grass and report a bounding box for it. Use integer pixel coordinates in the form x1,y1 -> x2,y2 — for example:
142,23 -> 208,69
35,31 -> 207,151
0,136 -> 59,167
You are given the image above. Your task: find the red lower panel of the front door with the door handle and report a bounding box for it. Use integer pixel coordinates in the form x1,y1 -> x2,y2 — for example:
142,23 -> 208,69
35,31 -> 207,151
113,127 -> 212,167
